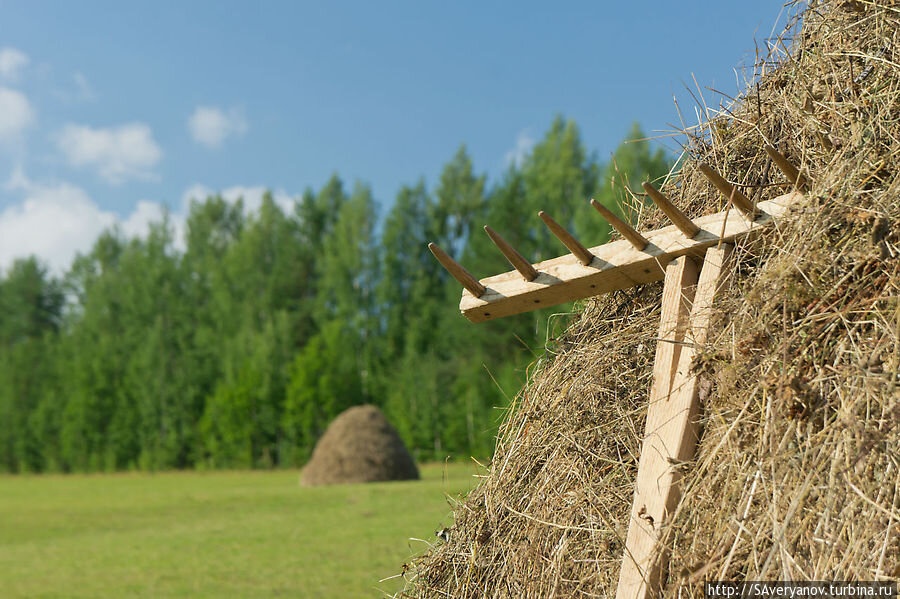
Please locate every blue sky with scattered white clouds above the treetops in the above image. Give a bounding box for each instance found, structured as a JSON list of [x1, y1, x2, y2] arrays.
[[0, 0, 783, 270]]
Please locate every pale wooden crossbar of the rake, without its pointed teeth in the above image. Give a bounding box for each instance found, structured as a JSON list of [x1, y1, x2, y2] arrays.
[[459, 192, 803, 322]]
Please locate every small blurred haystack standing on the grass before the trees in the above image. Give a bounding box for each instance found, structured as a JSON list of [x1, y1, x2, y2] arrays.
[[300, 405, 419, 486]]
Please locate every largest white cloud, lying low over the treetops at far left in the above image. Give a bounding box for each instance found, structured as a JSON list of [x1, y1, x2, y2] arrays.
[[0, 168, 184, 274]]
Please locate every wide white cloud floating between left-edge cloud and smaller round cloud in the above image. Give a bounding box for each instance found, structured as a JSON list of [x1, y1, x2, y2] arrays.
[[57, 123, 162, 184]]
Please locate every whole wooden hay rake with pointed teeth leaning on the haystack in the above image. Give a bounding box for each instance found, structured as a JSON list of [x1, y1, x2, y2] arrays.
[[428, 147, 807, 599]]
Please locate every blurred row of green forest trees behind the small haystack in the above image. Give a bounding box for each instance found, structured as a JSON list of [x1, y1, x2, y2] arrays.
[[0, 117, 672, 472]]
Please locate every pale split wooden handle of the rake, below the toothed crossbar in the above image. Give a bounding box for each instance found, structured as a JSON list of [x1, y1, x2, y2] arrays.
[[616, 244, 731, 599]]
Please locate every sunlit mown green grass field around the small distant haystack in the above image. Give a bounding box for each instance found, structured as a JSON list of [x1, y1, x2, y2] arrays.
[[0, 464, 475, 598]]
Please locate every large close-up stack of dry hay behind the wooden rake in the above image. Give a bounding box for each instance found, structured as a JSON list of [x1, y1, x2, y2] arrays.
[[404, 0, 900, 598]]
